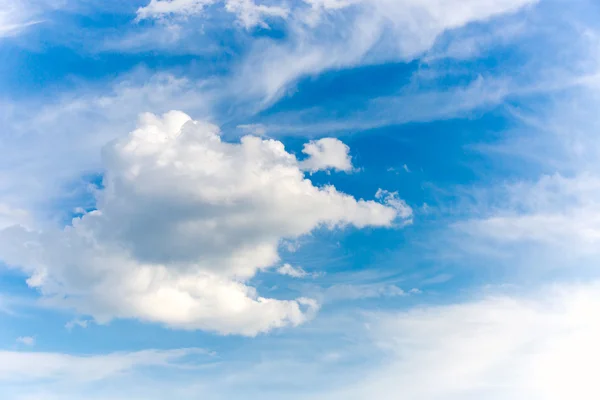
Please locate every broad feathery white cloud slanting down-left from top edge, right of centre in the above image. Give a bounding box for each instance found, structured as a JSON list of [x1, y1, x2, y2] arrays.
[[232, 0, 537, 105]]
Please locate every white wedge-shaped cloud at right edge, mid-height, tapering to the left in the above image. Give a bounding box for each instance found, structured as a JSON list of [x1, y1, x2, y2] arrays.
[[456, 174, 600, 254]]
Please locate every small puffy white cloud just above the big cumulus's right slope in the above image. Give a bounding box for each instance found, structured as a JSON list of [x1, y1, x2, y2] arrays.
[[300, 138, 353, 172]]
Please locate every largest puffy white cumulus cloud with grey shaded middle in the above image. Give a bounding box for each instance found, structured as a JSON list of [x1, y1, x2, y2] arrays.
[[0, 111, 410, 335]]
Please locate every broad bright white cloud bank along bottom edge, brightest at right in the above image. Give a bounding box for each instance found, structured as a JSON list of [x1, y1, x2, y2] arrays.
[[5, 282, 600, 400]]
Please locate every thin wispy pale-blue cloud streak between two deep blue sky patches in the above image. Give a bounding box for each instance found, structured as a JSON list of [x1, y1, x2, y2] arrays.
[[251, 71, 516, 136]]
